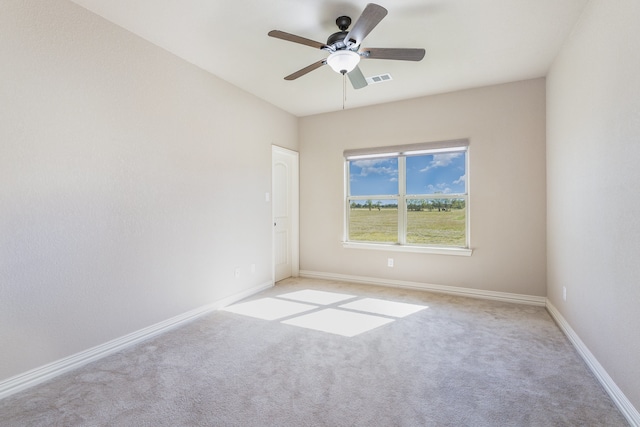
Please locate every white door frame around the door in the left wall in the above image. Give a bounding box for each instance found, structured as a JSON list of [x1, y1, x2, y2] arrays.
[[271, 145, 300, 284]]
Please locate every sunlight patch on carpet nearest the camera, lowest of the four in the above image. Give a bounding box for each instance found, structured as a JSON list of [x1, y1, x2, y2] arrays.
[[282, 308, 394, 337]]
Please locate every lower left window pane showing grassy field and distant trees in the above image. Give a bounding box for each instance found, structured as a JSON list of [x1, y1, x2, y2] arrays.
[[349, 200, 398, 243]]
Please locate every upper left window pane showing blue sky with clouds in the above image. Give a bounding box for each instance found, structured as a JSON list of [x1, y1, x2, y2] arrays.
[[349, 158, 398, 196]]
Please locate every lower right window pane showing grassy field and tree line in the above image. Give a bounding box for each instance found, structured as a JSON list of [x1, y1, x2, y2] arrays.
[[407, 199, 467, 247]]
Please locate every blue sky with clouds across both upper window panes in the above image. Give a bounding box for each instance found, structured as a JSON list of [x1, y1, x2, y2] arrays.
[[349, 152, 466, 196]]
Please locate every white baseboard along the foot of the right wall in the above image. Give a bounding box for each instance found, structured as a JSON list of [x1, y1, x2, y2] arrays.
[[546, 300, 640, 427]]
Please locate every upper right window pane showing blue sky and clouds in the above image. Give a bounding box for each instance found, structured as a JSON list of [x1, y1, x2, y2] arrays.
[[407, 151, 467, 194]]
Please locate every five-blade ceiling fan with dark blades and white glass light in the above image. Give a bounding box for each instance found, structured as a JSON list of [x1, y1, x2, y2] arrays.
[[269, 3, 425, 89]]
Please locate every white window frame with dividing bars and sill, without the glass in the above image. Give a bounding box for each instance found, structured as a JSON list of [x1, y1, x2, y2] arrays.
[[342, 139, 473, 256]]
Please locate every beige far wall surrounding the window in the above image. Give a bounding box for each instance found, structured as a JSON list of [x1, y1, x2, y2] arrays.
[[299, 79, 546, 296]]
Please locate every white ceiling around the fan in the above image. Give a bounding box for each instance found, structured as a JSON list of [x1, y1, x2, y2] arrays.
[[72, 0, 588, 117]]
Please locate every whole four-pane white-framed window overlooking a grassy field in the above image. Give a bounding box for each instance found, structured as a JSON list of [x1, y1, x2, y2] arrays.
[[345, 140, 470, 255]]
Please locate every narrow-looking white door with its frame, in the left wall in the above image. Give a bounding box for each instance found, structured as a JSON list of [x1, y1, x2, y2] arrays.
[[271, 146, 299, 282]]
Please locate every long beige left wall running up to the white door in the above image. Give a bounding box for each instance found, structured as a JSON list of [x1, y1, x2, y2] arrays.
[[0, 0, 297, 381]]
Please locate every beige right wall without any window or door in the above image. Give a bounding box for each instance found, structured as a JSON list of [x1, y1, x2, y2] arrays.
[[547, 0, 640, 408]]
